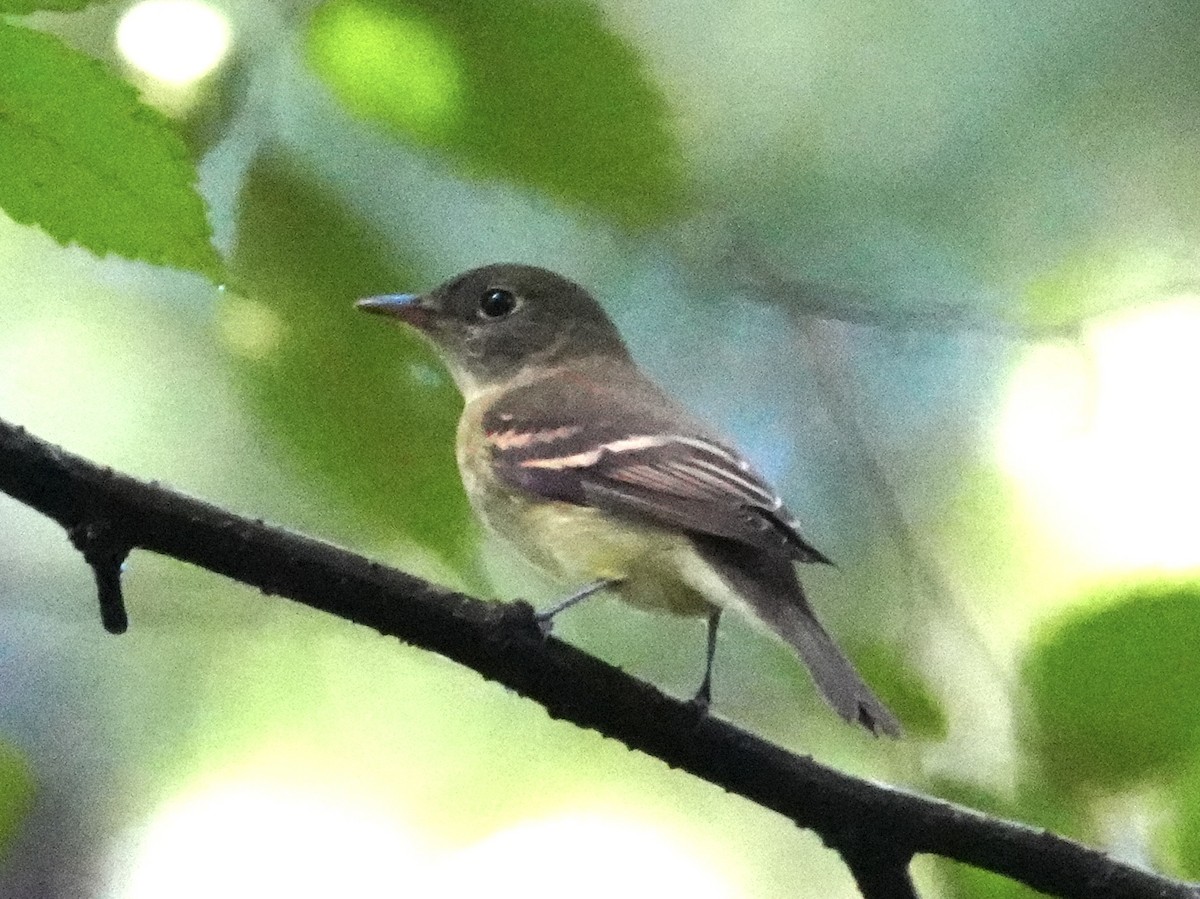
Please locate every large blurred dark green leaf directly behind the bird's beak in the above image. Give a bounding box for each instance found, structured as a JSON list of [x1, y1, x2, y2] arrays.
[[222, 156, 475, 558]]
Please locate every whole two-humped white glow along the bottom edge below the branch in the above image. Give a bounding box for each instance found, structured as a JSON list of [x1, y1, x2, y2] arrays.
[[107, 781, 742, 899]]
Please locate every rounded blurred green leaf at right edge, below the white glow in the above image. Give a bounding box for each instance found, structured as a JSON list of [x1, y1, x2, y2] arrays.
[[1024, 585, 1200, 789]]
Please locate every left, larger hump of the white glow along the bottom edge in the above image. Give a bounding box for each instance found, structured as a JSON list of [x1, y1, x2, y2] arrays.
[[114, 784, 426, 899]]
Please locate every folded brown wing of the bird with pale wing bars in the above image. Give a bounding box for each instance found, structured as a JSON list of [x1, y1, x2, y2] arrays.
[[482, 376, 828, 562]]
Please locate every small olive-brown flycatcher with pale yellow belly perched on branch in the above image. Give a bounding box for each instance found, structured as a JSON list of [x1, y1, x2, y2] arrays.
[[359, 265, 900, 736]]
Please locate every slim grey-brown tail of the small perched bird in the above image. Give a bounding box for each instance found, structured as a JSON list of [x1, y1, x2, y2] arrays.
[[697, 540, 901, 737]]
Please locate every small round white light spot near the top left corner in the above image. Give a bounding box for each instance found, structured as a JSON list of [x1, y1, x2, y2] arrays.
[[116, 0, 230, 86]]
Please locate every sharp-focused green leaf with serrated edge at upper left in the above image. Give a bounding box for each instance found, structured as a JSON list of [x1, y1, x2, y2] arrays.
[[0, 22, 221, 280]]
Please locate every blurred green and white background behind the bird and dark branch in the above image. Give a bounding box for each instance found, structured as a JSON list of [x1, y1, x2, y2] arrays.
[[0, 0, 1200, 899]]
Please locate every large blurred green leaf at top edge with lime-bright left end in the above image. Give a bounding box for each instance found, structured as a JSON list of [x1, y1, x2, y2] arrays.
[[307, 0, 683, 227]]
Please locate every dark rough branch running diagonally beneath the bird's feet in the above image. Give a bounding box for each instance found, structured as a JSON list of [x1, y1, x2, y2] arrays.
[[0, 421, 1200, 899]]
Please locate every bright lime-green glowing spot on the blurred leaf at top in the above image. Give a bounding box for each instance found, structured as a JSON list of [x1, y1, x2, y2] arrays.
[[308, 0, 462, 137]]
